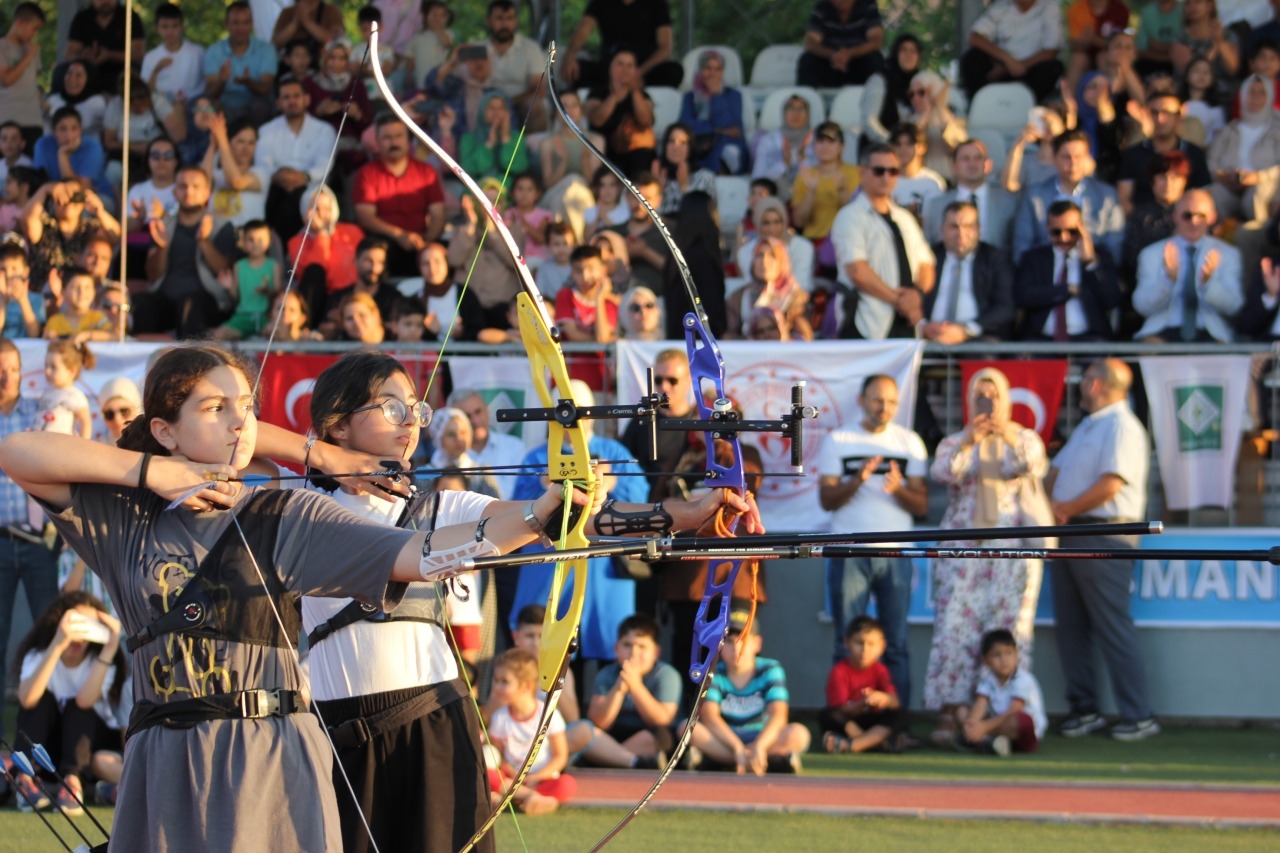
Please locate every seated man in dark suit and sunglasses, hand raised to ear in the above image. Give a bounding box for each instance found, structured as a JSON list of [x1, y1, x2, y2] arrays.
[[1014, 201, 1121, 343]]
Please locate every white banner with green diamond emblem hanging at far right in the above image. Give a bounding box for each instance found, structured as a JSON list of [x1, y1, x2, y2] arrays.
[[1138, 356, 1249, 510]]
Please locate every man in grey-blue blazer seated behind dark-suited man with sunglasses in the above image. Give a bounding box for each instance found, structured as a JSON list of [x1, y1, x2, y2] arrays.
[[1014, 131, 1124, 263]]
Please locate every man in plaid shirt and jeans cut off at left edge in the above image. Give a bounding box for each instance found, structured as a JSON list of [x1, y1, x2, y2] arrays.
[[0, 337, 58, 732]]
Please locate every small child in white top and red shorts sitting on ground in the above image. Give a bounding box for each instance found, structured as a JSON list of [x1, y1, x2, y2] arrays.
[[489, 648, 577, 815]]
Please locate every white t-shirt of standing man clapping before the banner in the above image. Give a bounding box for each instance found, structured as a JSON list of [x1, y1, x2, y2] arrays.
[[817, 423, 929, 533]]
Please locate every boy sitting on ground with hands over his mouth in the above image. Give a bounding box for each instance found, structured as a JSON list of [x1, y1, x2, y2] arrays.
[[586, 613, 684, 770]]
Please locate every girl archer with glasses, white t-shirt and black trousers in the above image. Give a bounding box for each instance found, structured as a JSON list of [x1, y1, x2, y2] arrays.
[[292, 351, 754, 853]]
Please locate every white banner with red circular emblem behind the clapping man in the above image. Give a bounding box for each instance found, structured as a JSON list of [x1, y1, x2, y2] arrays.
[[617, 339, 924, 532]]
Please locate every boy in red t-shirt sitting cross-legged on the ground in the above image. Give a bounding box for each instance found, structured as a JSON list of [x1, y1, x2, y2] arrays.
[[819, 616, 905, 752]]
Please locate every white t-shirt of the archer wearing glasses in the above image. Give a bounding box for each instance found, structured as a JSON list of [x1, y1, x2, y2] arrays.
[[302, 481, 493, 702]]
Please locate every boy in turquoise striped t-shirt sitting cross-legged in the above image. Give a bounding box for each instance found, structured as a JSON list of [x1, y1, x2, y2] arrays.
[[686, 610, 809, 776]]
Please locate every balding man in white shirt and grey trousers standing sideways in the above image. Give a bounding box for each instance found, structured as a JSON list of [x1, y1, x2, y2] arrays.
[[1044, 359, 1160, 740]]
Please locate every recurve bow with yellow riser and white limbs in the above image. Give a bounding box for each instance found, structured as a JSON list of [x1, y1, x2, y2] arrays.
[[369, 24, 595, 853]]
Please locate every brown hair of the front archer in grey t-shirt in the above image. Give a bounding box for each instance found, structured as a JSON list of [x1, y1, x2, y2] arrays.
[[117, 343, 257, 456]]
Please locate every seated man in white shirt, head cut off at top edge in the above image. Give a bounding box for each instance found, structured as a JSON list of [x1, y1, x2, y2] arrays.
[[960, 0, 1062, 102]]
